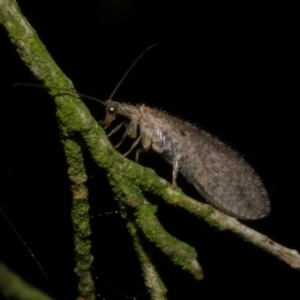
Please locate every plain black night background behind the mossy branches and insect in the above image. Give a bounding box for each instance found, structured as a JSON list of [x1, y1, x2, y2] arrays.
[[0, 0, 300, 300]]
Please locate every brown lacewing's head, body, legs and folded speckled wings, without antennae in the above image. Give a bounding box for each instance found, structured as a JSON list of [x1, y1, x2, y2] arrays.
[[99, 100, 270, 220]]
